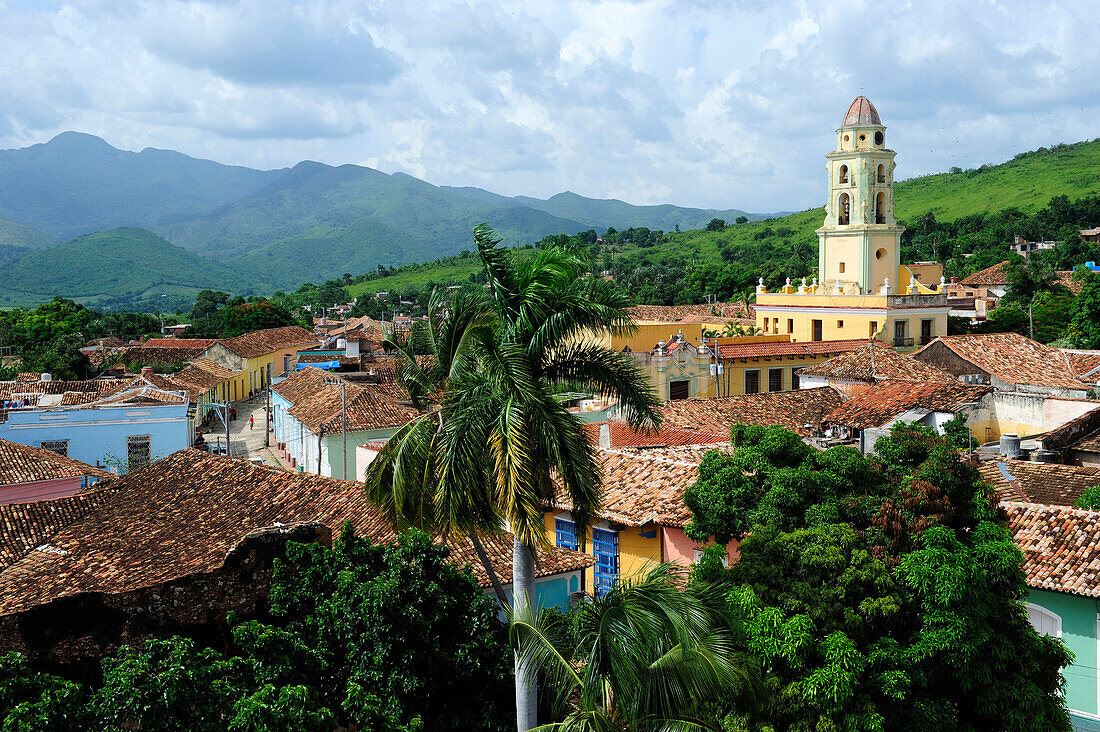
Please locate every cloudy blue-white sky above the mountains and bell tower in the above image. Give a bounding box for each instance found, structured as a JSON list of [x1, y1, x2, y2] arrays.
[[0, 0, 1100, 211]]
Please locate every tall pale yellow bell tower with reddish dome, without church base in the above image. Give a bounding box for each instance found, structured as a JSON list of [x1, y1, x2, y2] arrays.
[[817, 97, 904, 295]]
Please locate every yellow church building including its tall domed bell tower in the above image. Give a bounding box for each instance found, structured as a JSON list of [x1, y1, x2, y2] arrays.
[[756, 97, 949, 348]]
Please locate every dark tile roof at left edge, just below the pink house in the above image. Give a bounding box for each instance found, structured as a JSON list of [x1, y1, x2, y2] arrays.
[[0, 485, 113, 572]]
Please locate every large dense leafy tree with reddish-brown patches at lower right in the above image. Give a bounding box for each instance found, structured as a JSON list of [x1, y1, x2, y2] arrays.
[[685, 426, 1071, 732]]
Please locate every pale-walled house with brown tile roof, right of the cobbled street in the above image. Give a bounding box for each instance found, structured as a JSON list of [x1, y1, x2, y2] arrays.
[[272, 368, 418, 478]]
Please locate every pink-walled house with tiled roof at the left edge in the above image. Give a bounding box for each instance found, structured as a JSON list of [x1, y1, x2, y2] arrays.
[[0, 439, 111, 504]]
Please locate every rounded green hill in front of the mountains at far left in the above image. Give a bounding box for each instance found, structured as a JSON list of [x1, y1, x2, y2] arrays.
[[0, 229, 255, 310]]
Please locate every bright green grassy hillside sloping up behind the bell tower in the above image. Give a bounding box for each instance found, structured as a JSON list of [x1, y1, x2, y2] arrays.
[[354, 141, 1100, 294]]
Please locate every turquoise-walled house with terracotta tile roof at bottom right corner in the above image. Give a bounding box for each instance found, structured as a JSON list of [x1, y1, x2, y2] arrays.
[[1001, 502, 1100, 732]]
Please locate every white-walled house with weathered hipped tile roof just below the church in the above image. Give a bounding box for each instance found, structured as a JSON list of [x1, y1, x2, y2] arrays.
[[799, 340, 956, 396]]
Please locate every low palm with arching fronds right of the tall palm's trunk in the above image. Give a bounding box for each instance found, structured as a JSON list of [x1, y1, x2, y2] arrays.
[[509, 565, 760, 732]]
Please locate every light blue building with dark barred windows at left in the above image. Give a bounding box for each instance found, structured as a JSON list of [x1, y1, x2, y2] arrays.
[[0, 376, 190, 472]]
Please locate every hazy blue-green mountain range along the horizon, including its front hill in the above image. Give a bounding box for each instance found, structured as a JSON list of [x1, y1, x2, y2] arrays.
[[0, 132, 765, 309]]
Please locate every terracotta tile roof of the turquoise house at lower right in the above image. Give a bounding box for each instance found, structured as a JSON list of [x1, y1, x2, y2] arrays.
[[1001, 503, 1100, 598]]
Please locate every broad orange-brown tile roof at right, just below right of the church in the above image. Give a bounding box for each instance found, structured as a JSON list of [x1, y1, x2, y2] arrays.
[[913, 332, 1087, 390]]
